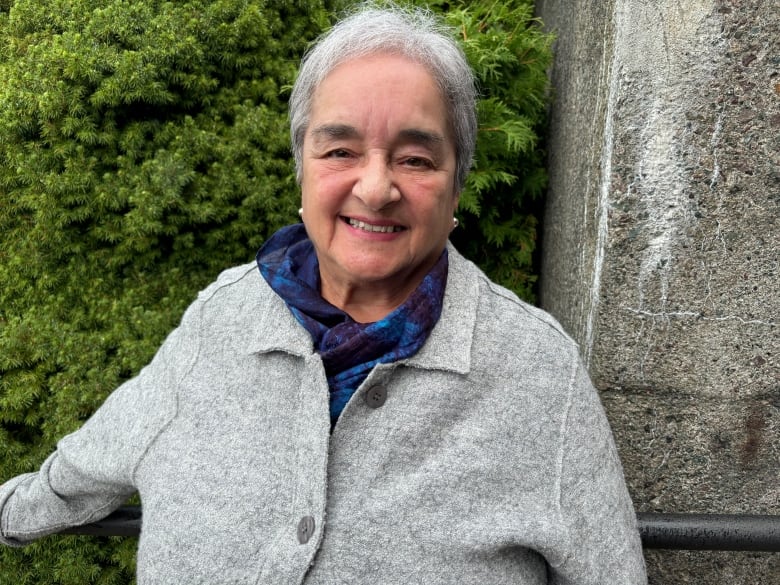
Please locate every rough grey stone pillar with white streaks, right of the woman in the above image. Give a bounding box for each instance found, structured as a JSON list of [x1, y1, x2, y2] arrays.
[[537, 0, 780, 585]]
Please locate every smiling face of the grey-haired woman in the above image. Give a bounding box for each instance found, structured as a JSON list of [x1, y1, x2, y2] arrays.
[[301, 55, 458, 308]]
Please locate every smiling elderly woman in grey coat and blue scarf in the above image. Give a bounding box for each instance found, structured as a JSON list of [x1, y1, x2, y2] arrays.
[[0, 2, 645, 585]]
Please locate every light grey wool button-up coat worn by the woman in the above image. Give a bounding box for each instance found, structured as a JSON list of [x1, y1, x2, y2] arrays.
[[0, 242, 645, 585]]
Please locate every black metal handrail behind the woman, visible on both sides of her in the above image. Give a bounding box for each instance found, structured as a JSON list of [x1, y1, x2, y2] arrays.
[[62, 506, 780, 552]]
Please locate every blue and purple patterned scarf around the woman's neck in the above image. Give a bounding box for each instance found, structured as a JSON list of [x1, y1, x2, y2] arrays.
[[257, 223, 448, 424]]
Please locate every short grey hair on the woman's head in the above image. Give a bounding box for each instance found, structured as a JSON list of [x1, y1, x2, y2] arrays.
[[289, 2, 477, 191]]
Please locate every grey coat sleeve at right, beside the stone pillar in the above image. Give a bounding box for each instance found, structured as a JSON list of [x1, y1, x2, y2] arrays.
[[550, 363, 647, 585]]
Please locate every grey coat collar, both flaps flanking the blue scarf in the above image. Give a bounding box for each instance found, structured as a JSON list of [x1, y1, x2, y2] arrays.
[[248, 244, 479, 374]]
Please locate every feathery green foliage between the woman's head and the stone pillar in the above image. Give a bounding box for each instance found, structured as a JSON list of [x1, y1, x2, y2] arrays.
[[438, 0, 552, 301]]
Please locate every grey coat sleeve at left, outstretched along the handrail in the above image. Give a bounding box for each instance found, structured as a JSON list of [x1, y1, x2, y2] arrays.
[[0, 296, 198, 546]]
